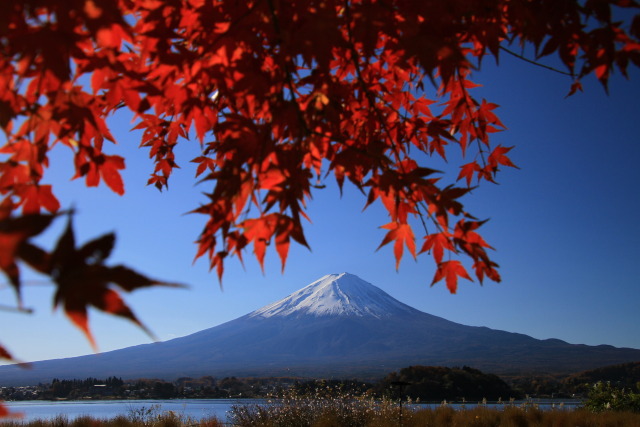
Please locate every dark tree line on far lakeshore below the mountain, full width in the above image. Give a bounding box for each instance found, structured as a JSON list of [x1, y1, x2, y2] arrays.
[[5, 362, 640, 402]]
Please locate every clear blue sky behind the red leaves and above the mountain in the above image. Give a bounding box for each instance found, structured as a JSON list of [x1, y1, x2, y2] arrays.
[[0, 50, 640, 360]]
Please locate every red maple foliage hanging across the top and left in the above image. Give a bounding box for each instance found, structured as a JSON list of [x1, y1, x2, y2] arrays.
[[0, 0, 640, 382]]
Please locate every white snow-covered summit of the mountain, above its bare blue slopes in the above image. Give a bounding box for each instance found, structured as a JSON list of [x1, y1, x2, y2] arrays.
[[249, 273, 416, 318]]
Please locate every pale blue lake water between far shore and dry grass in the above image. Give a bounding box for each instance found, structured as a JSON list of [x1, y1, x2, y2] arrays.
[[0, 399, 580, 424]]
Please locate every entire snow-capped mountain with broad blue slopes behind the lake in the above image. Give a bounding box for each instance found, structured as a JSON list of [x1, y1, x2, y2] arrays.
[[0, 273, 640, 386]]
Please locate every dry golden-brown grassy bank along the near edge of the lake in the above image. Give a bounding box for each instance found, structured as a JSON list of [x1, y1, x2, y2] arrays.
[[1, 402, 640, 427]]
